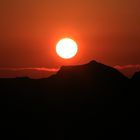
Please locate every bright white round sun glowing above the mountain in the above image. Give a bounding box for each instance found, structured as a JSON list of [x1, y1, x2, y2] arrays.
[[56, 38, 78, 59]]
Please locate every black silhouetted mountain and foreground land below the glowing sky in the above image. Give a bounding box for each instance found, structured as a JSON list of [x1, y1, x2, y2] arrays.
[[0, 61, 140, 140]]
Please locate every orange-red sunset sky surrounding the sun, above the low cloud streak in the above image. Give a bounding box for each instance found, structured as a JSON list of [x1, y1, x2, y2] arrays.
[[0, 0, 140, 77]]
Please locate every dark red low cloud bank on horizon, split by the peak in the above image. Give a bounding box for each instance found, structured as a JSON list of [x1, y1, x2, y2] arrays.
[[0, 61, 140, 79]]
